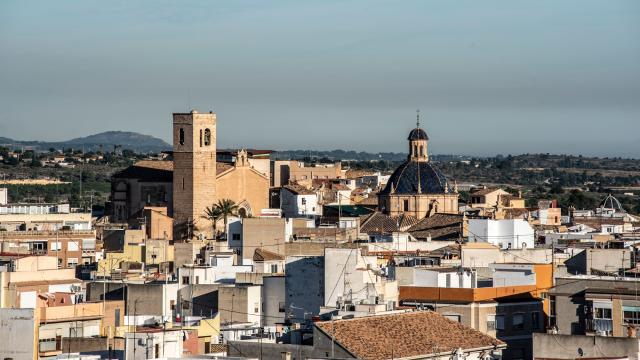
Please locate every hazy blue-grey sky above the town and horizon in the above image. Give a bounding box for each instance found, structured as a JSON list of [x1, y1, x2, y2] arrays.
[[0, 0, 640, 157]]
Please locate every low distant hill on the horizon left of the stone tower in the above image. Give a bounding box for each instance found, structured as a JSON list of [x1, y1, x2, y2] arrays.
[[0, 131, 171, 153]]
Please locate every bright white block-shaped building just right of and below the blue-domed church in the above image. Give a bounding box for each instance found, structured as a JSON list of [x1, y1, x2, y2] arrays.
[[469, 219, 535, 249]]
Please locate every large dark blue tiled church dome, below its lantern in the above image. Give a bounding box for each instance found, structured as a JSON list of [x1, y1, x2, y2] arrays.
[[380, 160, 452, 195]]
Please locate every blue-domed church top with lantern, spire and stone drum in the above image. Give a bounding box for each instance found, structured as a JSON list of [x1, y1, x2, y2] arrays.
[[378, 118, 458, 219]]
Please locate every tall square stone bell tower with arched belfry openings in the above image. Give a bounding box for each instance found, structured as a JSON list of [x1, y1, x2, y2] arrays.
[[173, 110, 217, 240]]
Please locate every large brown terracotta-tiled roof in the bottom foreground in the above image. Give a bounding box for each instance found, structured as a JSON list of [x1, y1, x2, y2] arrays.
[[316, 311, 504, 359]]
